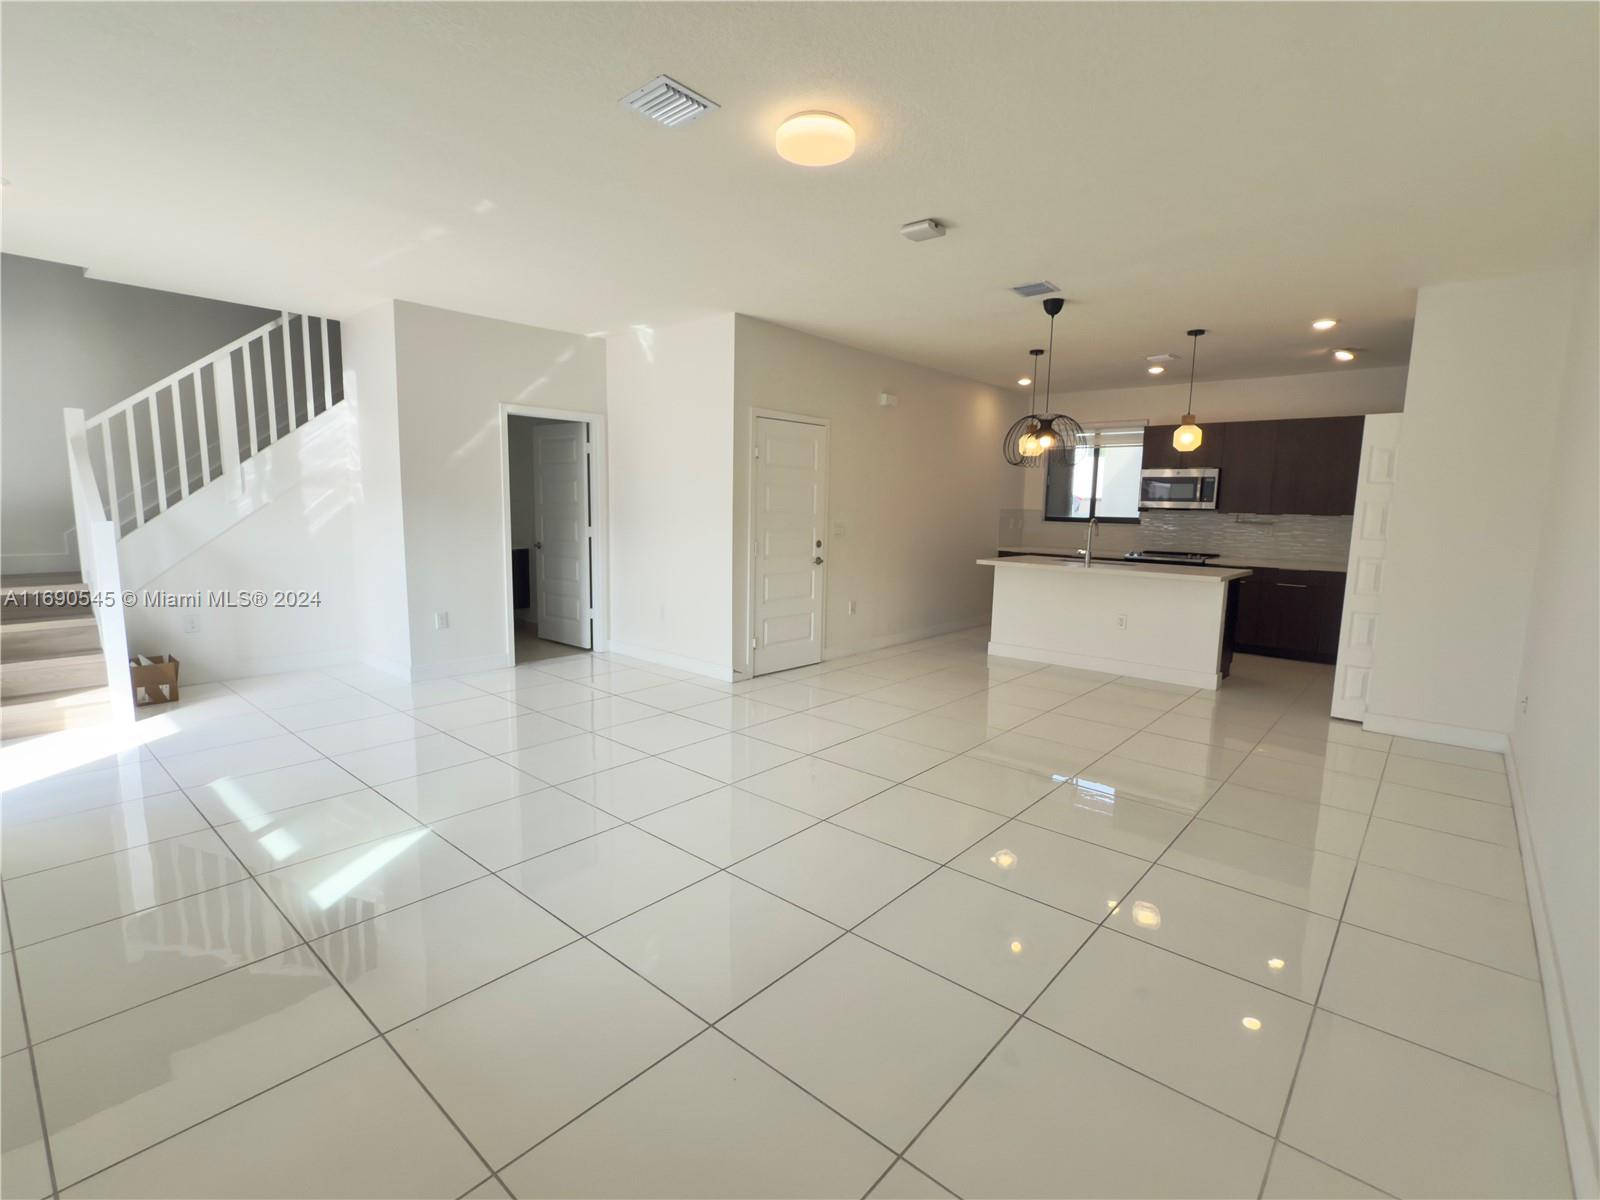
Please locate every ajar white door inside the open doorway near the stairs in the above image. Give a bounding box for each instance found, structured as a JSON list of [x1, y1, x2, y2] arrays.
[[533, 421, 592, 650]]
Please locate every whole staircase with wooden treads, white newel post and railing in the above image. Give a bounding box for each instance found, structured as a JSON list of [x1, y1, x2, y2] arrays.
[[0, 312, 349, 738]]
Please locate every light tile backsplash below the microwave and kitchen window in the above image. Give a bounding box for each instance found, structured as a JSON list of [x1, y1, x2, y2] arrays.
[[998, 509, 1355, 570]]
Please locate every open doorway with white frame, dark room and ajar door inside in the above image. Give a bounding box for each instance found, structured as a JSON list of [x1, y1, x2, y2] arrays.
[[501, 405, 605, 662]]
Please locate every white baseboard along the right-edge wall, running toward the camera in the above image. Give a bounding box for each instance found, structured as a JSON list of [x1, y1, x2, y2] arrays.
[[1506, 746, 1600, 1197]]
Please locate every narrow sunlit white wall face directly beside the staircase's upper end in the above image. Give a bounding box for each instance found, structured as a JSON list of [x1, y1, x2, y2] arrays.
[[341, 301, 411, 675]]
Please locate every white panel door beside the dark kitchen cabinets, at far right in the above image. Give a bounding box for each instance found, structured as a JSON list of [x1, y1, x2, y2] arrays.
[[1333, 413, 1400, 722]]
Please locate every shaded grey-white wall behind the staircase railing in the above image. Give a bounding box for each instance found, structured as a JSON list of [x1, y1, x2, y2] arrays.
[[0, 254, 277, 574]]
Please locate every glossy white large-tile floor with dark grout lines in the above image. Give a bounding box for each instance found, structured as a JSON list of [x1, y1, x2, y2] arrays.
[[0, 630, 1570, 1200]]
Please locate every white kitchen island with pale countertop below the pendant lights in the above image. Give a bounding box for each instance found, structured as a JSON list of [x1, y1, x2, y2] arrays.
[[978, 555, 1250, 690]]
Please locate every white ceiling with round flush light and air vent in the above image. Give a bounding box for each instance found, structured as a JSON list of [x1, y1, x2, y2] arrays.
[[0, 3, 1600, 387]]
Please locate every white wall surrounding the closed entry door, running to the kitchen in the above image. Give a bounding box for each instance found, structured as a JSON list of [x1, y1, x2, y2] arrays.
[[733, 315, 1034, 670]]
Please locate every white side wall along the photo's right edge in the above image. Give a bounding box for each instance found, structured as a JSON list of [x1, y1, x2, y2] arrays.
[[1510, 224, 1600, 1195]]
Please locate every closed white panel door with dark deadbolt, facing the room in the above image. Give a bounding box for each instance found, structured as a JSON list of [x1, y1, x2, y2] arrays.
[[750, 416, 827, 675]]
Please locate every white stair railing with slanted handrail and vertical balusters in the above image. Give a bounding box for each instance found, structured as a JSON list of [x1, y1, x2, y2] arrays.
[[83, 312, 342, 538]]
